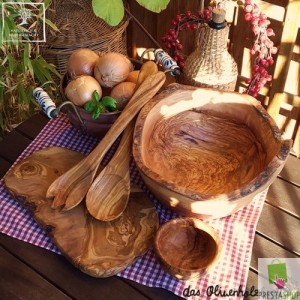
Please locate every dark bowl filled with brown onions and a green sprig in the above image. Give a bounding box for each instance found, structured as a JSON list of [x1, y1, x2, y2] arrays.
[[60, 48, 140, 137]]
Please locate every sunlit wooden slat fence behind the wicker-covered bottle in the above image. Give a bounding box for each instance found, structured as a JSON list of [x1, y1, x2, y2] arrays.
[[128, 0, 300, 157]]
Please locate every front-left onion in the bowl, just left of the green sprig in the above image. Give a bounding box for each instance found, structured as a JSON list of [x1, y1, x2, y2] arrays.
[[65, 75, 102, 106]]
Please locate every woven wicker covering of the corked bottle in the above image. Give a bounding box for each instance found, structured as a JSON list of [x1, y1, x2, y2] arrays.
[[181, 24, 238, 91]]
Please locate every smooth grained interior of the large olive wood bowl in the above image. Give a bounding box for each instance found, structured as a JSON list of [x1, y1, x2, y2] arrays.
[[139, 84, 288, 196]]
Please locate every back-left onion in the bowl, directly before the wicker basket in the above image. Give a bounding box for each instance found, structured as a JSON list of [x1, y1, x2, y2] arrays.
[[67, 48, 99, 78]]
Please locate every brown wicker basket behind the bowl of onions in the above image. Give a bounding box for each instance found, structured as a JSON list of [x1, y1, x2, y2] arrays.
[[42, 0, 129, 75]]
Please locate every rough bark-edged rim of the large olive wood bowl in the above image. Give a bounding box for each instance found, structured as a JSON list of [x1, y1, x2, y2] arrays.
[[133, 83, 292, 201]]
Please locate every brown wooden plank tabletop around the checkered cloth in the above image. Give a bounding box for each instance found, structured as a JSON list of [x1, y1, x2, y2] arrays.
[[0, 114, 300, 300]]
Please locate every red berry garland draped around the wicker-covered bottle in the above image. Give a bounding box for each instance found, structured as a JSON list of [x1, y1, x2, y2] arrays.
[[162, 0, 278, 97]]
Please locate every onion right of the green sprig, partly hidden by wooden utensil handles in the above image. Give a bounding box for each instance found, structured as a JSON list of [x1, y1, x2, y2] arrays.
[[110, 81, 136, 110]]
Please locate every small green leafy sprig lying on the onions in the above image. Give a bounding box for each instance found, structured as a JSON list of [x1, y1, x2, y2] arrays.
[[84, 90, 118, 120]]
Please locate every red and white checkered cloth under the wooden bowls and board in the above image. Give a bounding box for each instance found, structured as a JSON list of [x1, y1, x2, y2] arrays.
[[0, 114, 267, 299]]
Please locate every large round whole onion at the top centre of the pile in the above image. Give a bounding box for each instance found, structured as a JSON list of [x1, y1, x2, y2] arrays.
[[94, 52, 133, 87]]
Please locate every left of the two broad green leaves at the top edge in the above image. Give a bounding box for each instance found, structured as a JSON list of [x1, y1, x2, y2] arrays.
[[92, 0, 124, 26]]
